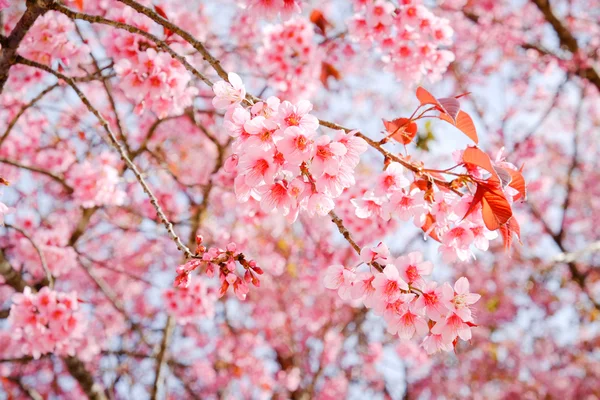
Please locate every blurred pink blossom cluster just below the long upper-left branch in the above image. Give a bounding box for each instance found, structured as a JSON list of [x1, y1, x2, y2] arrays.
[[115, 48, 198, 118]]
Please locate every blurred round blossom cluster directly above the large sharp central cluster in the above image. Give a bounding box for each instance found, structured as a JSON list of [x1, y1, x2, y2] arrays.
[[256, 18, 323, 99]]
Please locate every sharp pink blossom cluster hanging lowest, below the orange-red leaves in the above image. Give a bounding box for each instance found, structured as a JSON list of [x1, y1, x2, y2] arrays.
[[324, 244, 481, 353]]
